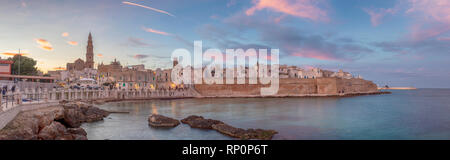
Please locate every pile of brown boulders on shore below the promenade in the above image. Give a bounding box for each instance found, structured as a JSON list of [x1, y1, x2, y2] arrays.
[[0, 102, 109, 140]]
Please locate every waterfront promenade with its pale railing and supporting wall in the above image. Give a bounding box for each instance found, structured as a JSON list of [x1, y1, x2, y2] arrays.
[[0, 88, 199, 129]]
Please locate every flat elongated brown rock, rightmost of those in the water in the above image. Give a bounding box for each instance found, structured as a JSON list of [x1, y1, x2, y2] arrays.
[[212, 124, 278, 140]]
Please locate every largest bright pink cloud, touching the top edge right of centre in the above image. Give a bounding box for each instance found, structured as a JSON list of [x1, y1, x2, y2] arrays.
[[245, 0, 329, 22]]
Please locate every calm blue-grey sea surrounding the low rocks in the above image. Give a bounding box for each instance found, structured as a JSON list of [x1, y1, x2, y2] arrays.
[[82, 89, 450, 140]]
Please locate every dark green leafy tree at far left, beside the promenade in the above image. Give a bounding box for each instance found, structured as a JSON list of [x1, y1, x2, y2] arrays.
[[8, 55, 38, 76]]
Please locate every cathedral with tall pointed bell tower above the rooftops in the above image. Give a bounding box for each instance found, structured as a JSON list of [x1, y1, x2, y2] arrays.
[[66, 33, 94, 71]]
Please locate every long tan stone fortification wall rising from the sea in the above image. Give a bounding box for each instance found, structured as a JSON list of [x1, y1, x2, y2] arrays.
[[195, 77, 378, 97]]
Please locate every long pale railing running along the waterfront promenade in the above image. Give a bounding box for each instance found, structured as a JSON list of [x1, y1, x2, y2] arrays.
[[0, 88, 198, 112]]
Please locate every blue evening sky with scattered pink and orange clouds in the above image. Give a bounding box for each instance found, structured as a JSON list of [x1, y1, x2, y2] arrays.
[[0, 0, 450, 88]]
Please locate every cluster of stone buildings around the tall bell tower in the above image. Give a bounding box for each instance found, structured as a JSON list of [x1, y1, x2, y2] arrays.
[[48, 33, 174, 89]]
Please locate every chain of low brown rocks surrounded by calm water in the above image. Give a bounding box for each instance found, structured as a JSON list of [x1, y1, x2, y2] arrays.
[[148, 114, 278, 140]]
